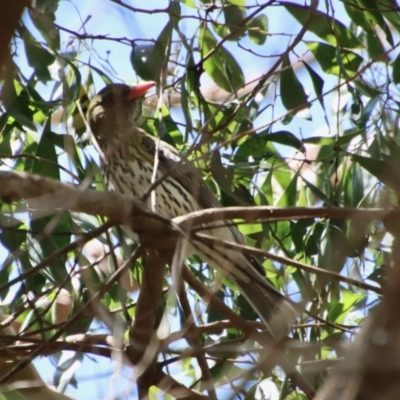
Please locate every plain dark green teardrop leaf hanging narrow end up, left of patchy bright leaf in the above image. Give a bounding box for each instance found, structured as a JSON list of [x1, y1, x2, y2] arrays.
[[280, 54, 307, 110]]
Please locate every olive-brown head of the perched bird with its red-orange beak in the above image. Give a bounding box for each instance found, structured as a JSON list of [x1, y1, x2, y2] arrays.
[[87, 82, 155, 140]]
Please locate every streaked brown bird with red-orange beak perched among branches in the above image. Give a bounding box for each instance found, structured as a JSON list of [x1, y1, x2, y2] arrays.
[[87, 82, 299, 340]]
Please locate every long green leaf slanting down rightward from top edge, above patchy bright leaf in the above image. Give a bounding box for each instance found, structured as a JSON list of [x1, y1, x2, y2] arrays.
[[283, 2, 362, 48]]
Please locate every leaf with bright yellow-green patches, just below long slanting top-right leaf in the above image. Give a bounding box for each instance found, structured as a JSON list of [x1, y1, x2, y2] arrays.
[[306, 42, 363, 76]]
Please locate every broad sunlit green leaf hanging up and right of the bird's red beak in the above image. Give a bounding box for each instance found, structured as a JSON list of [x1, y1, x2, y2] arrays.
[[200, 25, 244, 93]]
